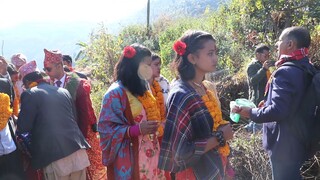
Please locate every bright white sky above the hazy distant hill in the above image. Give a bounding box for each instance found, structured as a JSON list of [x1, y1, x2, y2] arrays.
[[0, 0, 147, 29]]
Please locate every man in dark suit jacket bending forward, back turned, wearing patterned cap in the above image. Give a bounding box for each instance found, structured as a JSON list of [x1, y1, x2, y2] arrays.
[[17, 61, 90, 179]]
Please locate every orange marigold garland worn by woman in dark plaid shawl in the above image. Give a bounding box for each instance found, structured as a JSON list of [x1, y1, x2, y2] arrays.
[[202, 90, 230, 157]]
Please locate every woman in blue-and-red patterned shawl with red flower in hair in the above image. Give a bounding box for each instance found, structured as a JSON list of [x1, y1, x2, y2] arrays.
[[98, 44, 165, 179]]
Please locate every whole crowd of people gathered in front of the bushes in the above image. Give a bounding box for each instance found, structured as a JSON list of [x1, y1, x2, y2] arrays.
[[0, 27, 312, 180]]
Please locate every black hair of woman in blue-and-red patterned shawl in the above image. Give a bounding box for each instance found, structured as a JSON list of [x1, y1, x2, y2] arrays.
[[114, 43, 151, 96]]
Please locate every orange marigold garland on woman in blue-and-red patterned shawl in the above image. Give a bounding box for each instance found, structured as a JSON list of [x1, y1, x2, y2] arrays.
[[138, 91, 164, 137]]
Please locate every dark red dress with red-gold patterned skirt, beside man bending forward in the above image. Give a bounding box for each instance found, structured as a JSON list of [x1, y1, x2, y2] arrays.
[[63, 73, 107, 180]]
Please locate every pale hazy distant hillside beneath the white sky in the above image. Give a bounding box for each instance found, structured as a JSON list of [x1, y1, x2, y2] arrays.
[[0, 0, 218, 68]]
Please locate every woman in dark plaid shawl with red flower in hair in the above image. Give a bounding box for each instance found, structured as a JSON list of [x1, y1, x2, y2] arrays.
[[158, 31, 233, 179]]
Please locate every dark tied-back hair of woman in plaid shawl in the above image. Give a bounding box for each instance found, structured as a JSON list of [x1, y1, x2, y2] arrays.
[[172, 30, 215, 81]]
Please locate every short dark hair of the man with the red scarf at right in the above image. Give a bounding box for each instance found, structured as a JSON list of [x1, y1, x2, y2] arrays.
[[284, 26, 311, 49]]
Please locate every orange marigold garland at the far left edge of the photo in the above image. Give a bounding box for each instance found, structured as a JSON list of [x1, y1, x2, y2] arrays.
[[0, 93, 12, 130]]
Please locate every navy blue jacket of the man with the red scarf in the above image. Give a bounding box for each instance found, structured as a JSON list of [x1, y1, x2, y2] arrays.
[[250, 57, 312, 158]]
